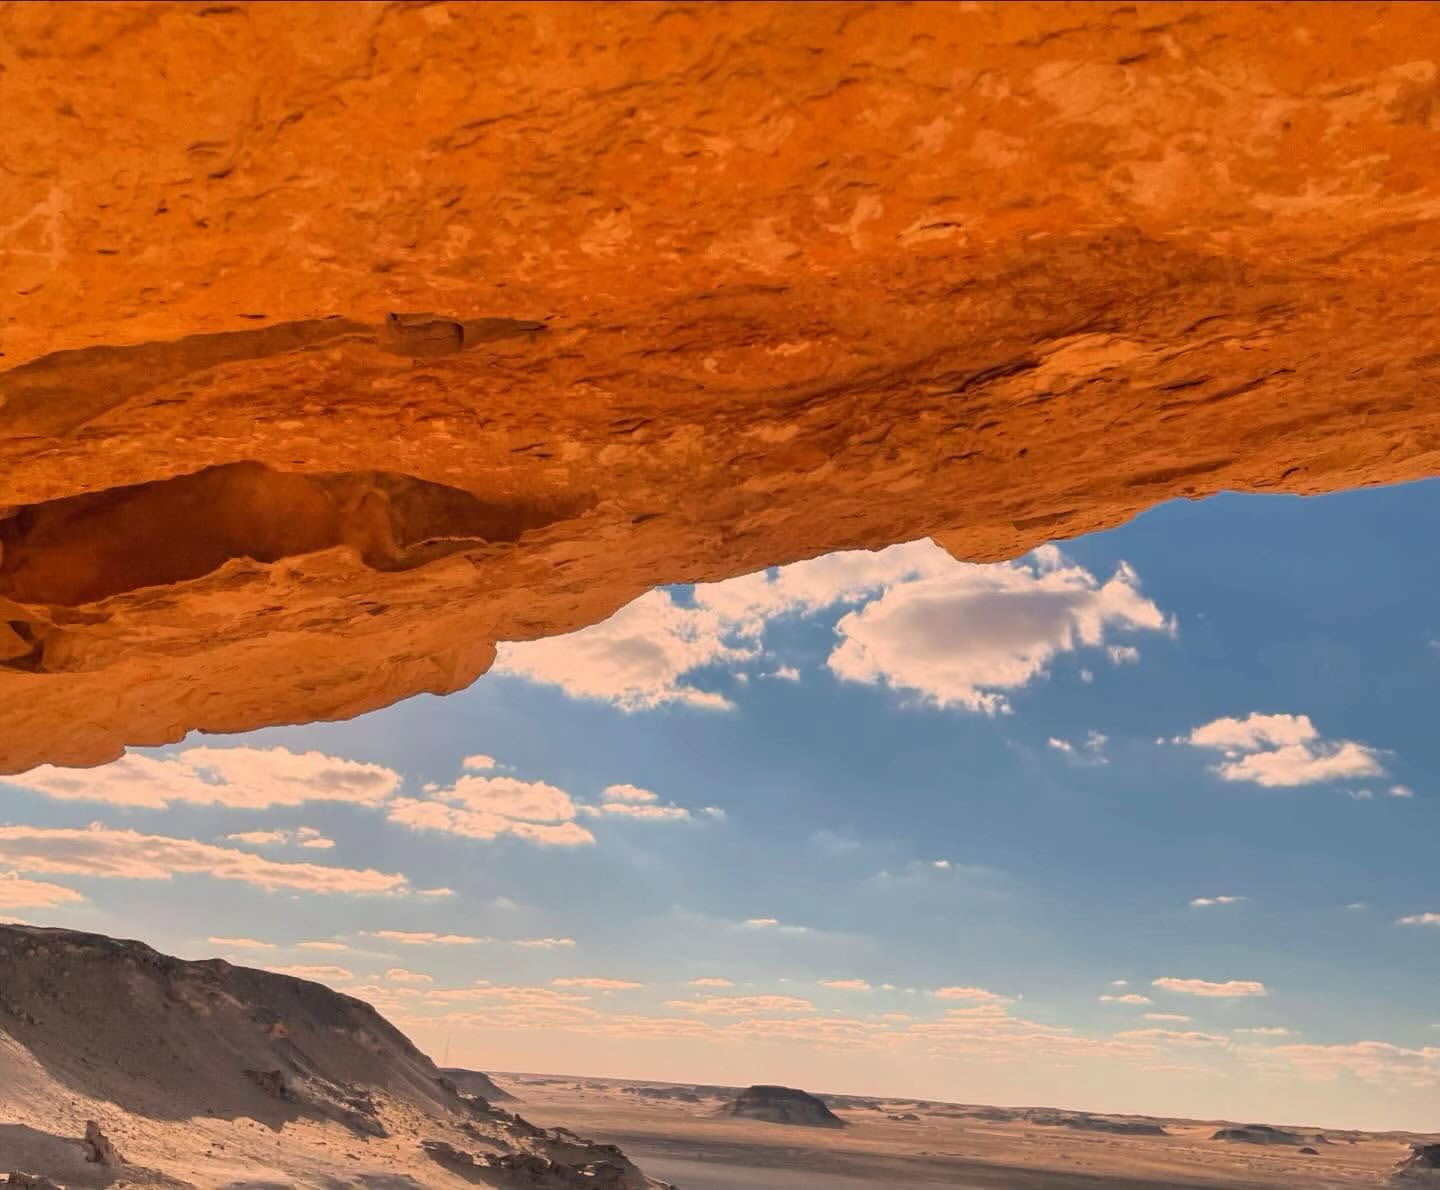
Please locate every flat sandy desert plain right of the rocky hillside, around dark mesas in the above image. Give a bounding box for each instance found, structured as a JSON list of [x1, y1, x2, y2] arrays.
[[495, 1075, 1410, 1190]]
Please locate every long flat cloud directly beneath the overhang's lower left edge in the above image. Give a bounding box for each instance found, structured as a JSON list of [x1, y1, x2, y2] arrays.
[[4, 748, 400, 810]]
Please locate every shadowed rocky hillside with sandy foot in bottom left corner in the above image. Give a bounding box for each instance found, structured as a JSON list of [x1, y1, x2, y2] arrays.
[[0, 925, 660, 1190]]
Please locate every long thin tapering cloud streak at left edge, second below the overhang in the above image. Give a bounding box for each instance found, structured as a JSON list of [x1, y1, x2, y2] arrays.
[[0, 823, 406, 893]]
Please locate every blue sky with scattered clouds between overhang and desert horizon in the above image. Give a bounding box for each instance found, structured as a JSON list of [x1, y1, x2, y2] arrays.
[[0, 484, 1440, 1128]]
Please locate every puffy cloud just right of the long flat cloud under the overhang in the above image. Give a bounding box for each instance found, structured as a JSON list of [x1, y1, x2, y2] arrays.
[[386, 775, 595, 847]]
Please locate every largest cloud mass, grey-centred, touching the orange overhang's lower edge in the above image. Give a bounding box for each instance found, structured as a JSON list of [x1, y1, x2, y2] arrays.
[[495, 542, 1174, 712]]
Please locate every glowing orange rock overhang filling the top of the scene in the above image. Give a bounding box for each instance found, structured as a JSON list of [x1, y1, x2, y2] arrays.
[[0, 3, 1440, 771]]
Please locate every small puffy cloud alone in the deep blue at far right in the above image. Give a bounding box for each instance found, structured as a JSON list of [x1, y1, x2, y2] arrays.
[[1175, 712, 1385, 788]]
